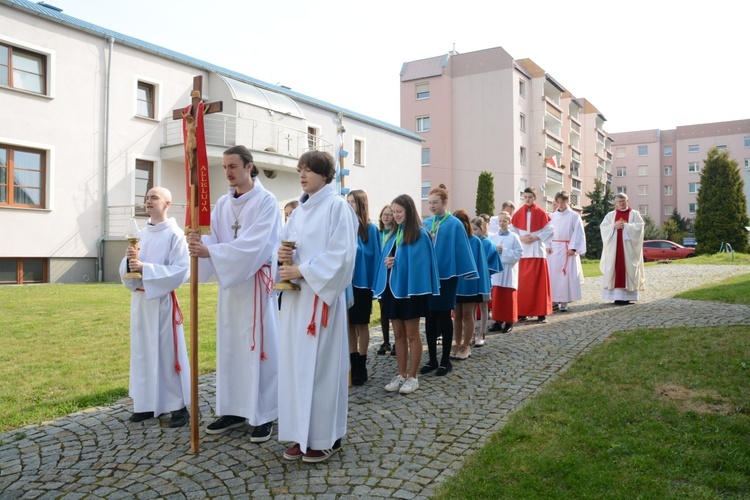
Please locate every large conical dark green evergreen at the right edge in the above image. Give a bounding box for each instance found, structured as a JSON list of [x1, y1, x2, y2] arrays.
[[694, 147, 750, 254]]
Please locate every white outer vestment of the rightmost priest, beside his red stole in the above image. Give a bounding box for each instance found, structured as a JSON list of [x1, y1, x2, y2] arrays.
[[599, 208, 646, 300]]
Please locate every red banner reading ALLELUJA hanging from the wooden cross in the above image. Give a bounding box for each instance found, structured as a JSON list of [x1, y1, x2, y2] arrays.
[[182, 102, 211, 234]]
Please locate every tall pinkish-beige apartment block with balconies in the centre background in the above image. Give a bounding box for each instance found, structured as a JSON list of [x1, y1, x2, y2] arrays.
[[400, 47, 612, 216]]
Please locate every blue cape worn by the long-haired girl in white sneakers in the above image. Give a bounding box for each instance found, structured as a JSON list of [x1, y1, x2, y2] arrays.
[[374, 227, 440, 299]]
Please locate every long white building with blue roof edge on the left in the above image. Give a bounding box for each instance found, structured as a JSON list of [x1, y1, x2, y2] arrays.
[[0, 0, 422, 283]]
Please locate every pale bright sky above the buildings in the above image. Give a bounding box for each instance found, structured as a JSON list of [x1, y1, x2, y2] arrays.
[[46, 0, 750, 133]]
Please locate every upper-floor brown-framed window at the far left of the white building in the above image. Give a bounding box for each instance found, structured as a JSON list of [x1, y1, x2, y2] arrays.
[[0, 43, 47, 94]]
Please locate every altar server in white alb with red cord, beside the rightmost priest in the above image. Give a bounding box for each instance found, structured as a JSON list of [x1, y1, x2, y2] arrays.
[[547, 191, 586, 312]]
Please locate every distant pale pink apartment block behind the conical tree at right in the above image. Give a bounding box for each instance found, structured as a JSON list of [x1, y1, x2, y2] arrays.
[[611, 120, 750, 224]]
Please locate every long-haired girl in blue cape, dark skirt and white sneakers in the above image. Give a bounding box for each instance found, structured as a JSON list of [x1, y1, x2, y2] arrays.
[[375, 194, 440, 394]]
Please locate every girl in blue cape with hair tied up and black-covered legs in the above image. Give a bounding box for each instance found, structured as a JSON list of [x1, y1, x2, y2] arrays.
[[420, 184, 479, 376]]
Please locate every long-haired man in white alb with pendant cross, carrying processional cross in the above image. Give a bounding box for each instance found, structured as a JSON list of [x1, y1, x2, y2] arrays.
[[188, 146, 286, 443]]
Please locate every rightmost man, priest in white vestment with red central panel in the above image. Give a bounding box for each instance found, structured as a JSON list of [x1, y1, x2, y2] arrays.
[[599, 193, 646, 305]]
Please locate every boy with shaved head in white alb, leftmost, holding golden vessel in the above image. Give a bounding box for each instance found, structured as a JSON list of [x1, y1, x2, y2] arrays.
[[120, 187, 190, 427]]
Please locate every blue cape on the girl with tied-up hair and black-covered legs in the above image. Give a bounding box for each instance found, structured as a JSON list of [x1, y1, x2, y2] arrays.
[[424, 215, 479, 280]]
